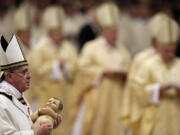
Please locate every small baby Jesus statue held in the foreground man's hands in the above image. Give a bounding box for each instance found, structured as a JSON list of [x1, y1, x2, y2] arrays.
[[31, 97, 63, 127]]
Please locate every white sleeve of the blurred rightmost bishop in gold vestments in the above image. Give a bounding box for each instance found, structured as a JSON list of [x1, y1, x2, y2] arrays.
[[150, 83, 160, 104]]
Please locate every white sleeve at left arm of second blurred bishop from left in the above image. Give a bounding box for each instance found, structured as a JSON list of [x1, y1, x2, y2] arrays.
[[50, 60, 62, 80]]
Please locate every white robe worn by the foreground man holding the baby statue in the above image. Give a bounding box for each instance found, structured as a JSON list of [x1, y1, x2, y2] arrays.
[[0, 81, 34, 135]]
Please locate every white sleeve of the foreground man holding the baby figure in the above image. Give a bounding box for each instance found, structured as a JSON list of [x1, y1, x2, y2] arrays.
[[0, 107, 34, 135]]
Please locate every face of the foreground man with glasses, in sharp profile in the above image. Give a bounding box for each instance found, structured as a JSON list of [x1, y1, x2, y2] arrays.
[[7, 66, 32, 93]]
